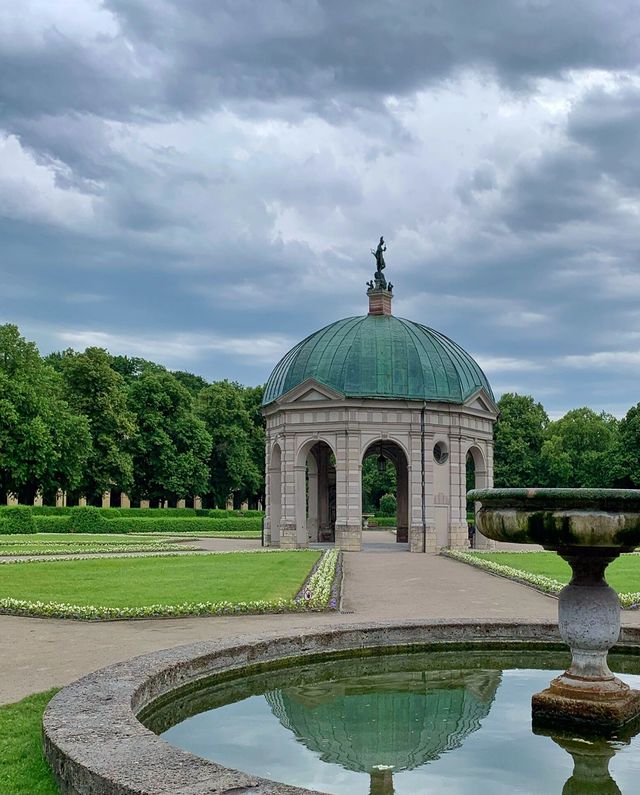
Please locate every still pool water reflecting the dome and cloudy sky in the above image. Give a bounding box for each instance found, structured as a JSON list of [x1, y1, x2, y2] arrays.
[[142, 651, 640, 795]]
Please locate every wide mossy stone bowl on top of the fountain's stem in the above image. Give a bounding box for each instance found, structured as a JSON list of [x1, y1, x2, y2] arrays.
[[467, 488, 640, 552]]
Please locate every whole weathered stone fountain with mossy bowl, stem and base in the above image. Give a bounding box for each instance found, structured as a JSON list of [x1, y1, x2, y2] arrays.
[[469, 489, 640, 731]]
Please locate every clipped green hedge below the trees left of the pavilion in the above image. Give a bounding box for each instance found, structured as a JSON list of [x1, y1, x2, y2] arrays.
[[0, 506, 262, 535]]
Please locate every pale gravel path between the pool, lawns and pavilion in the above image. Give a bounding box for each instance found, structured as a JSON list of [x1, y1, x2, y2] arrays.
[[0, 531, 640, 703]]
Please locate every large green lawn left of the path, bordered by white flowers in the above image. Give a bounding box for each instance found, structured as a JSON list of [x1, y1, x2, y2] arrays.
[[0, 550, 320, 607]]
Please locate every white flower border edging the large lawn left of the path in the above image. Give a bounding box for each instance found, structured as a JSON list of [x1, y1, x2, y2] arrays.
[[0, 549, 340, 621]]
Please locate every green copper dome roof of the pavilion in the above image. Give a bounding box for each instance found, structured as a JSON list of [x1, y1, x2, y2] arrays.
[[263, 315, 493, 405]]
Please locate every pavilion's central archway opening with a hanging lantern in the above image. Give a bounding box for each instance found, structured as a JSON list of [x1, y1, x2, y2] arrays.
[[362, 439, 409, 543]]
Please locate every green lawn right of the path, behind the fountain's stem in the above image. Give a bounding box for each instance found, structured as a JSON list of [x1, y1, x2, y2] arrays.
[[470, 552, 640, 593]]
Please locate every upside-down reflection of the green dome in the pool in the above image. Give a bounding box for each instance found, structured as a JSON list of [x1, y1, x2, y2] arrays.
[[265, 671, 500, 795]]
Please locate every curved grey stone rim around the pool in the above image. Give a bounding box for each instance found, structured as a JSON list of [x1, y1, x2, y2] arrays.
[[43, 621, 640, 795]]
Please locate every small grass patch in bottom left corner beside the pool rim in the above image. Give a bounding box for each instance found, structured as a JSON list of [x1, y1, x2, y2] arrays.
[[0, 690, 58, 795]]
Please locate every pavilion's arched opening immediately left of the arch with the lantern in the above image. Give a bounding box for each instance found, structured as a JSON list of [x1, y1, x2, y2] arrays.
[[295, 435, 336, 546]]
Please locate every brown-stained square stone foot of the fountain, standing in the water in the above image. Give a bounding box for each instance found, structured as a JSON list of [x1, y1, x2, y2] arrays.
[[531, 674, 640, 731]]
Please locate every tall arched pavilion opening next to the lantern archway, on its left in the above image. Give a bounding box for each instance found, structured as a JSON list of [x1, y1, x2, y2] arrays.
[[301, 441, 336, 543]]
